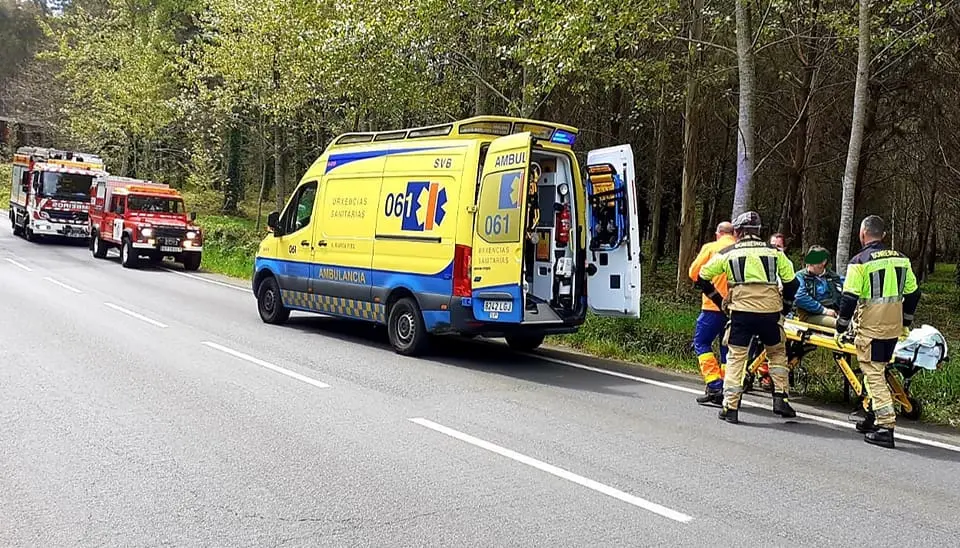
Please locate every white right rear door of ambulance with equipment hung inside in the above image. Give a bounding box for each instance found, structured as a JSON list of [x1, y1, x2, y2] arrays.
[[586, 145, 642, 318]]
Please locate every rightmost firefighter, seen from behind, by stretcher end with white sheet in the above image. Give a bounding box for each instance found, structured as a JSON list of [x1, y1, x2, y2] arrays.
[[837, 215, 920, 448]]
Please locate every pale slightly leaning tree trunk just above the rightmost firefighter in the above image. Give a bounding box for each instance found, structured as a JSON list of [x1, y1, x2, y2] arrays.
[[837, 0, 870, 275]]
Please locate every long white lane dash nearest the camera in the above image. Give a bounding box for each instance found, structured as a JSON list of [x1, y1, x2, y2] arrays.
[[408, 418, 693, 523]]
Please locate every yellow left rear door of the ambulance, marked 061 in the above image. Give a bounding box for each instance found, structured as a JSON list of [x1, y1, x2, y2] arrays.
[[472, 133, 532, 323]]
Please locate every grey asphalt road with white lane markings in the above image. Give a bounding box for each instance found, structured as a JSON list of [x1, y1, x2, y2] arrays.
[[0, 223, 960, 547]]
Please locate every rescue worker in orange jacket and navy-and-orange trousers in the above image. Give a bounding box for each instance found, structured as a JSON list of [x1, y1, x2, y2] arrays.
[[687, 221, 737, 406]]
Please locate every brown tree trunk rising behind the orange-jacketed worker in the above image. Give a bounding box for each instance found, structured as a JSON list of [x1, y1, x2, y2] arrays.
[[677, 0, 704, 292]]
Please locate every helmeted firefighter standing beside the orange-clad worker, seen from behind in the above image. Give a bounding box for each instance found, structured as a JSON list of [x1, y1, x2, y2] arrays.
[[698, 211, 800, 424]]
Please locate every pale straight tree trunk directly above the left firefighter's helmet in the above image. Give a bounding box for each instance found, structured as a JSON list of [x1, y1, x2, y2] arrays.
[[732, 0, 756, 219]]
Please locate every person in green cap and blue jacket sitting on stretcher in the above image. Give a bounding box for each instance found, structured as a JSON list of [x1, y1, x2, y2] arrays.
[[794, 245, 843, 328]]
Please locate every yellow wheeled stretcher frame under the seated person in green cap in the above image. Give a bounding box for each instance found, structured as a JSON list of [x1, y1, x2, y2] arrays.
[[744, 318, 944, 420]]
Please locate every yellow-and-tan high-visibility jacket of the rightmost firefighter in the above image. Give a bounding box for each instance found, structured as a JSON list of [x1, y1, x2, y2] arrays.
[[837, 242, 920, 339]]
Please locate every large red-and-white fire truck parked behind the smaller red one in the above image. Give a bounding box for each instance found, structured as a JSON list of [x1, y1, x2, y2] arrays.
[[9, 147, 106, 241]]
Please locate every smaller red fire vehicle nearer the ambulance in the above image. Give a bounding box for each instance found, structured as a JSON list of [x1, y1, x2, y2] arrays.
[[90, 175, 203, 270]]
